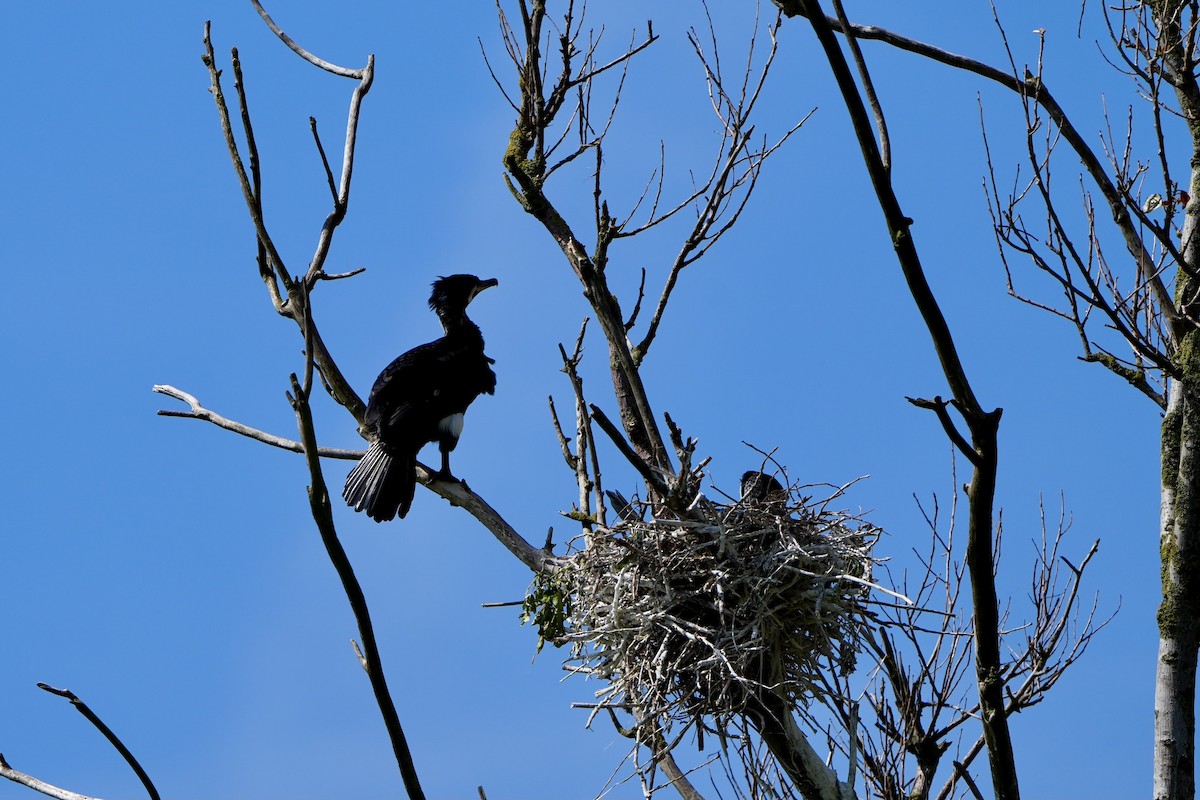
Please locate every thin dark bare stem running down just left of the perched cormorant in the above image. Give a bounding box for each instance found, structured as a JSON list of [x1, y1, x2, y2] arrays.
[[288, 309, 425, 800]]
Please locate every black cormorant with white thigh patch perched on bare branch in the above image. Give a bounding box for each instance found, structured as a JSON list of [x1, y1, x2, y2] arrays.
[[342, 275, 499, 522]]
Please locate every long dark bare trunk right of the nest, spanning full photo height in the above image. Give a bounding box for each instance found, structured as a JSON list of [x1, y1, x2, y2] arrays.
[[797, 0, 1020, 800]]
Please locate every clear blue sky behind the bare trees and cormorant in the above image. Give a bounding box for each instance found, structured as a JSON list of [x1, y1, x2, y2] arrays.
[[0, 0, 1161, 799]]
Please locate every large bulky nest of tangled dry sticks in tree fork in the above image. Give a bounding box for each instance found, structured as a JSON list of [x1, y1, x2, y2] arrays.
[[556, 482, 880, 729]]
